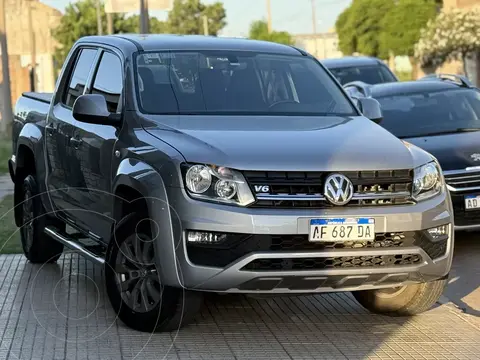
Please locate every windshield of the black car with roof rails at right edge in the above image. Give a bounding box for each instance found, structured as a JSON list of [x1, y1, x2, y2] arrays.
[[376, 89, 480, 137]]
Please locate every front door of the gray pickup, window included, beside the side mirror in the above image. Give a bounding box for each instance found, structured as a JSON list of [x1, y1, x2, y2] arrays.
[[66, 49, 124, 240]]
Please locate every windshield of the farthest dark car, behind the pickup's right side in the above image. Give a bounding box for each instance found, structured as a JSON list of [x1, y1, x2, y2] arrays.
[[329, 64, 397, 85]]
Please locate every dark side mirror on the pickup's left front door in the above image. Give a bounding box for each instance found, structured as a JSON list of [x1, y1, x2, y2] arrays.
[[72, 94, 120, 126]]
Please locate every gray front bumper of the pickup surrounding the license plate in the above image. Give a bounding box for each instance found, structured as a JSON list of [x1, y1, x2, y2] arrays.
[[159, 188, 454, 293]]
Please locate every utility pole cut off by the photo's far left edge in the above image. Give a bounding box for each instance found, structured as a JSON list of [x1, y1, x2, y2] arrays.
[[0, 0, 13, 133]]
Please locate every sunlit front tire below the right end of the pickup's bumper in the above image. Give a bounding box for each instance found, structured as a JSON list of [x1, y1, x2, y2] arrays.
[[352, 278, 447, 316]]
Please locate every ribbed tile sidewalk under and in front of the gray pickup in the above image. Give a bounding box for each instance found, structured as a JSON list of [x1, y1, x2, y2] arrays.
[[0, 250, 480, 360]]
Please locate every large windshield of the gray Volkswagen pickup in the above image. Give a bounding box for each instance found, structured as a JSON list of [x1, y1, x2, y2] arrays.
[[136, 51, 356, 115]]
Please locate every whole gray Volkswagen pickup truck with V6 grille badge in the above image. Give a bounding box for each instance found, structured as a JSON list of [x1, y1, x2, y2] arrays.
[[9, 35, 454, 331]]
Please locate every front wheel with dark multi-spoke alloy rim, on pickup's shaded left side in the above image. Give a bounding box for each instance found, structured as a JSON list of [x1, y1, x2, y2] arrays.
[[105, 212, 203, 333]]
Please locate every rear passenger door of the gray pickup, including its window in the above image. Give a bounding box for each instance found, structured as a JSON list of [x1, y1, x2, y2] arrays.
[[45, 47, 99, 219]]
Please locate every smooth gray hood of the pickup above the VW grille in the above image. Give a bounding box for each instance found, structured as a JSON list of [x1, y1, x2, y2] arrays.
[[145, 115, 430, 171]]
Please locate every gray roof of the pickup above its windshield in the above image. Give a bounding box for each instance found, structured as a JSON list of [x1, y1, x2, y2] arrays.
[[88, 34, 301, 55]]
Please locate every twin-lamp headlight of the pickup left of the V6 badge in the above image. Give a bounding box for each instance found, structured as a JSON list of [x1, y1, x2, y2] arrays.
[[183, 165, 255, 206]]
